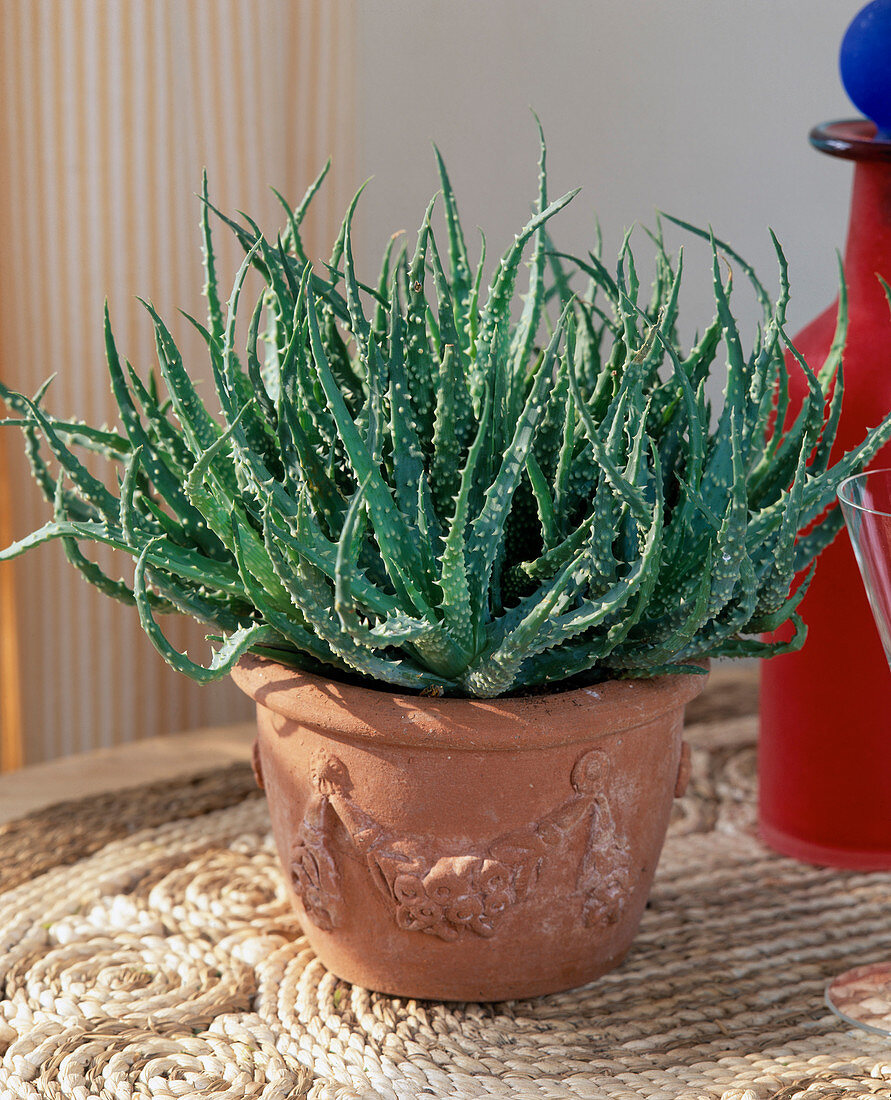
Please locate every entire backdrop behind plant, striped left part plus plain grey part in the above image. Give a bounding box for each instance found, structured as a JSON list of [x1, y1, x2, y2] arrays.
[[0, 0, 860, 759]]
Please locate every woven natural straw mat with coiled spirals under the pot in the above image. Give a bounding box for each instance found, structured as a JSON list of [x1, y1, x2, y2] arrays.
[[0, 678, 891, 1100]]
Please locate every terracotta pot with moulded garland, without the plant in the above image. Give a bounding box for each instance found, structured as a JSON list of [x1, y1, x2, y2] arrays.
[[233, 656, 705, 1001]]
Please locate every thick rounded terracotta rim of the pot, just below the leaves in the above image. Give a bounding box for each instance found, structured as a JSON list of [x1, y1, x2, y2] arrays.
[[231, 653, 708, 751]]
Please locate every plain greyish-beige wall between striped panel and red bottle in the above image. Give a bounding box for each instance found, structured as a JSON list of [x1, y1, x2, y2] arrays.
[[359, 0, 862, 352]]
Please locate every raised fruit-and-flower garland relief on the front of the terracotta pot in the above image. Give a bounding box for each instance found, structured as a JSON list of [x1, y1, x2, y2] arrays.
[[290, 749, 630, 941]]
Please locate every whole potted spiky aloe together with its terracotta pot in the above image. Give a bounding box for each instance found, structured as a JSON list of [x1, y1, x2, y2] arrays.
[[0, 133, 891, 1000]]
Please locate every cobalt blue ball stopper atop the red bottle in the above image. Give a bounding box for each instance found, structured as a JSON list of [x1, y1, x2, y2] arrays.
[[838, 0, 891, 138]]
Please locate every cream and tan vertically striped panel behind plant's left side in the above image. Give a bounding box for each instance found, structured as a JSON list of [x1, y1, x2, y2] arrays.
[[0, 0, 355, 767]]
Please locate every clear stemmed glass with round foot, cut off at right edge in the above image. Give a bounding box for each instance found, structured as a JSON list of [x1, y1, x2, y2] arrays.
[[826, 470, 891, 1035]]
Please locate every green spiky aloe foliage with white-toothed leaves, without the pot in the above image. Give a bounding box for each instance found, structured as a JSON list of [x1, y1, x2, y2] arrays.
[[0, 130, 891, 696]]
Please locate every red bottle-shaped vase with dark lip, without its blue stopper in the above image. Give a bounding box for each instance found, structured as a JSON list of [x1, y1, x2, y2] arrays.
[[759, 122, 891, 870]]
